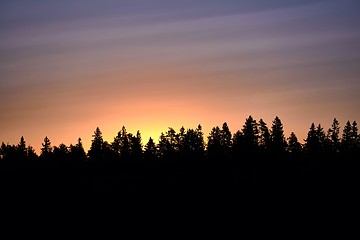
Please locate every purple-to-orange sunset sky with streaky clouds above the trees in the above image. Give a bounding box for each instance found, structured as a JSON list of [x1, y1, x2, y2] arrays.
[[0, 0, 360, 153]]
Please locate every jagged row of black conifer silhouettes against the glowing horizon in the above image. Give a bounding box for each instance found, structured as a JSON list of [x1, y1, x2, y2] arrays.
[[0, 116, 360, 168]]
